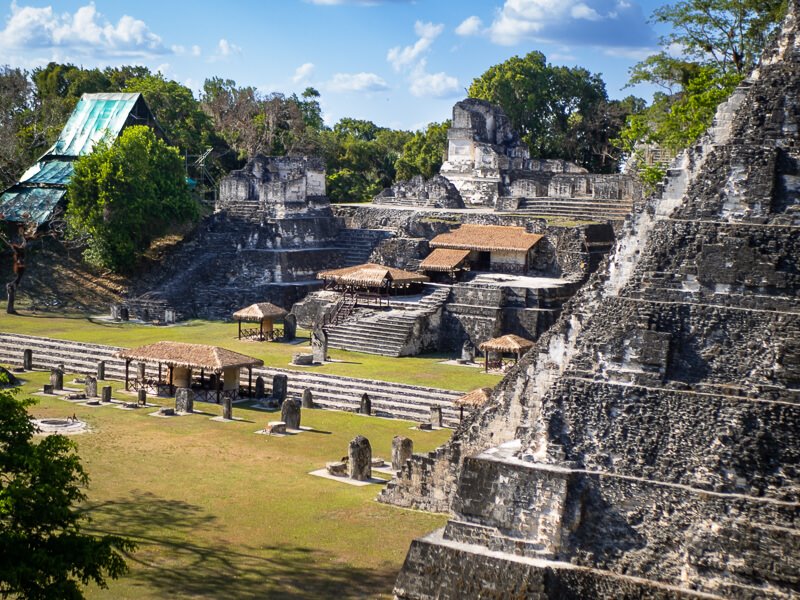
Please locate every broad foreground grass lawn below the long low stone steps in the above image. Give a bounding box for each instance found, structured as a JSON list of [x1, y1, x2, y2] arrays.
[[15, 372, 450, 599]]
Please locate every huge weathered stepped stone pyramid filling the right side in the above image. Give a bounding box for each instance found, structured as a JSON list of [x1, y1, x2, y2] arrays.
[[381, 5, 800, 599]]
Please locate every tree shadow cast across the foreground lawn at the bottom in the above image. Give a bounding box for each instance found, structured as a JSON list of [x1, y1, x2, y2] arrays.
[[84, 493, 396, 599]]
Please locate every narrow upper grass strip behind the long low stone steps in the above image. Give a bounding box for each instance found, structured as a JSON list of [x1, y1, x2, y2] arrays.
[[0, 310, 501, 392]]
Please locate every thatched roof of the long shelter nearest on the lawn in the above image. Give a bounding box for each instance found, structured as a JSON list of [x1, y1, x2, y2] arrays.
[[115, 342, 264, 372]]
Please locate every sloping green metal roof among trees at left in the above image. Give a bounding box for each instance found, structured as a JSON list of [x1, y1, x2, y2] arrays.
[[0, 93, 163, 225]]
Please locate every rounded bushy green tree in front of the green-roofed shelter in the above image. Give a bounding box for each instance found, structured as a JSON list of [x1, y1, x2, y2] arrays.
[[67, 126, 198, 272]]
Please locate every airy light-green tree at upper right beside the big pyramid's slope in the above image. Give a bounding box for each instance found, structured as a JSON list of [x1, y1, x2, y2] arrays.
[[616, 0, 786, 176]]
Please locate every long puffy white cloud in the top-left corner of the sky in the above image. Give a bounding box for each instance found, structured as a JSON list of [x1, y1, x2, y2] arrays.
[[0, 2, 170, 60]]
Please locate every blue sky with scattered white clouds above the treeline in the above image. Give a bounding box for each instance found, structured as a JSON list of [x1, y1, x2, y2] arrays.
[[0, 0, 676, 129]]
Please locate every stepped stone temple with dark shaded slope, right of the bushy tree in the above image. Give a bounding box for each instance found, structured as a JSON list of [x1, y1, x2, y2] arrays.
[[130, 156, 345, 320]]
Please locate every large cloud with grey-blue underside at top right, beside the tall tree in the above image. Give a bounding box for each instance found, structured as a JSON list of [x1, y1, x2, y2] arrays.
[[488, 0, 656, 48]]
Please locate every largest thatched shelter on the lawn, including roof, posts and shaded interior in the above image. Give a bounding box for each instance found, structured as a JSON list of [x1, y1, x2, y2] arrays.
[[115, 342, 264, 404]]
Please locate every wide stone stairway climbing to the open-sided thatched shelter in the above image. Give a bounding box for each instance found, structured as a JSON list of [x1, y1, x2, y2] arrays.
[[325, 284, 450, 357]]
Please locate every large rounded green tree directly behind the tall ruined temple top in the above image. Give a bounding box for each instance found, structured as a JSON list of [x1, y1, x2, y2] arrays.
[[469, 52, 622, 169]]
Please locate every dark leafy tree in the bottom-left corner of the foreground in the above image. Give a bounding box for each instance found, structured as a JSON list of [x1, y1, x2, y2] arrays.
[[0, 389, 135, 599]]
